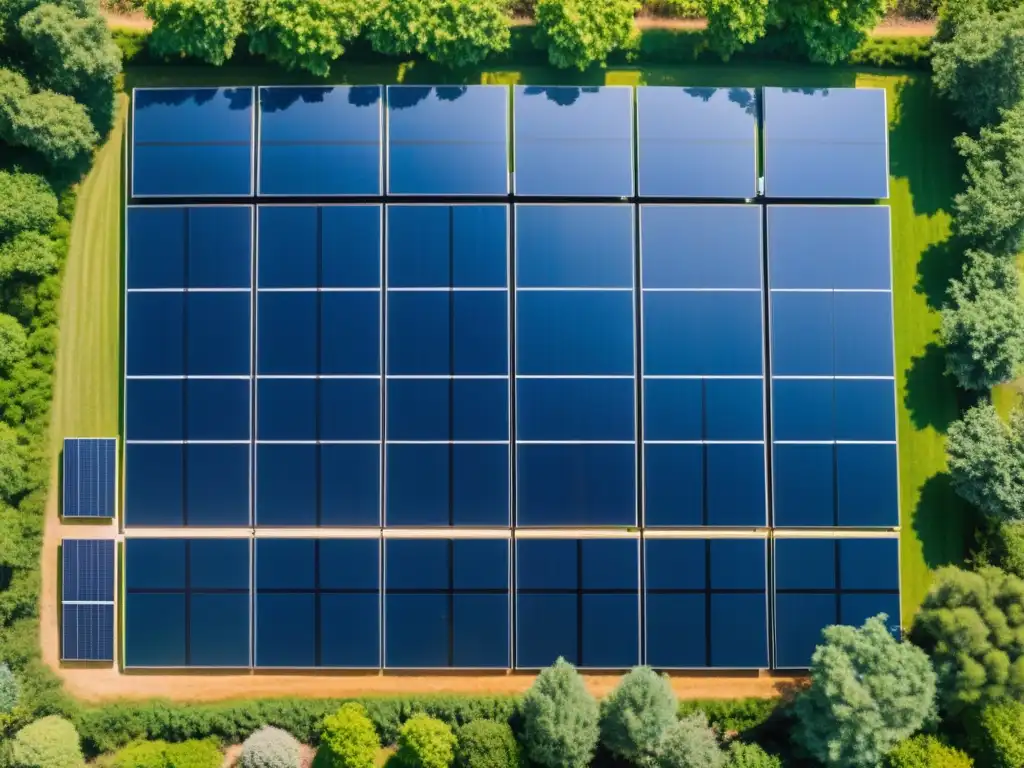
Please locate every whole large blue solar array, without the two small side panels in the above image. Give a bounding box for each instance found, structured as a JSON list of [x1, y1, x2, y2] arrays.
[[125, 86, 899, 669]]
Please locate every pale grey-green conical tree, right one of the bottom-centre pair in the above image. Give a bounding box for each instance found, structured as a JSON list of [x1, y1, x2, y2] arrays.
[[601, 667, 678, 767]]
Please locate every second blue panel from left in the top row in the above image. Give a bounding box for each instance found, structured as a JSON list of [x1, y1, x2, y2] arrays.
[[258, 85, 383, 196]]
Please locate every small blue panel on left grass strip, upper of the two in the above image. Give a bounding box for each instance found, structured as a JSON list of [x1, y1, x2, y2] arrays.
[[61, 437, 118, 517]]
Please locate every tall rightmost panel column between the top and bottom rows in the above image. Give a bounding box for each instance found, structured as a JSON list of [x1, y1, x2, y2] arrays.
[[768, 206, 899, 526]]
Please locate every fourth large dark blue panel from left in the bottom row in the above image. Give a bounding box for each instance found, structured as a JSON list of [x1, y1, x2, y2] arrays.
[[515, 539, 640, 669]]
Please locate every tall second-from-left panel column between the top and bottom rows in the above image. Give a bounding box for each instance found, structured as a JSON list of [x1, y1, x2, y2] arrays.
[[255, 205, 382, 526]]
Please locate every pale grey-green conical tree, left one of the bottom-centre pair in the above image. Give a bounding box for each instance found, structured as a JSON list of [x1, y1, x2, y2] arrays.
[[522, 658, 600, 768]]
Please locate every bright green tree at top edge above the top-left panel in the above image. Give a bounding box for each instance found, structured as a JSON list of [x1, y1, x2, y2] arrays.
[[145, 0, 245, 66]]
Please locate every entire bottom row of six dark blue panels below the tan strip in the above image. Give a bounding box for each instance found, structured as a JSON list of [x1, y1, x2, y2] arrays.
[[119, 539, 899, 669]]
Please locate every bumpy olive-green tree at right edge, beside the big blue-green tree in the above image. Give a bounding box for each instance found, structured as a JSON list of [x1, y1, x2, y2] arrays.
[[910, 566, 1024, 716]]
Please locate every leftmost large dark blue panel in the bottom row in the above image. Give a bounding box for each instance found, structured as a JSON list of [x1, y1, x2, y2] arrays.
[[124, 539, 251, 668]]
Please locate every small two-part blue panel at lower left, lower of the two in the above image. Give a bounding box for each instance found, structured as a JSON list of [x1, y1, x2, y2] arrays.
[[60, 539, 114, 662]]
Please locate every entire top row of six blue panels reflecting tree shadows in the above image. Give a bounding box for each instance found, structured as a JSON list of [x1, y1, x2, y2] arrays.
[[132, 85, 889, 200]]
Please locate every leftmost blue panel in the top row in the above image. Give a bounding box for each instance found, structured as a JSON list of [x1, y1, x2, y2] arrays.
[[132, 88, 255, 198]]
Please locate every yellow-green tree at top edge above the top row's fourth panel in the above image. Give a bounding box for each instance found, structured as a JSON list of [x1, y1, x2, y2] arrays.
[[534, 0, 640, 71]]
